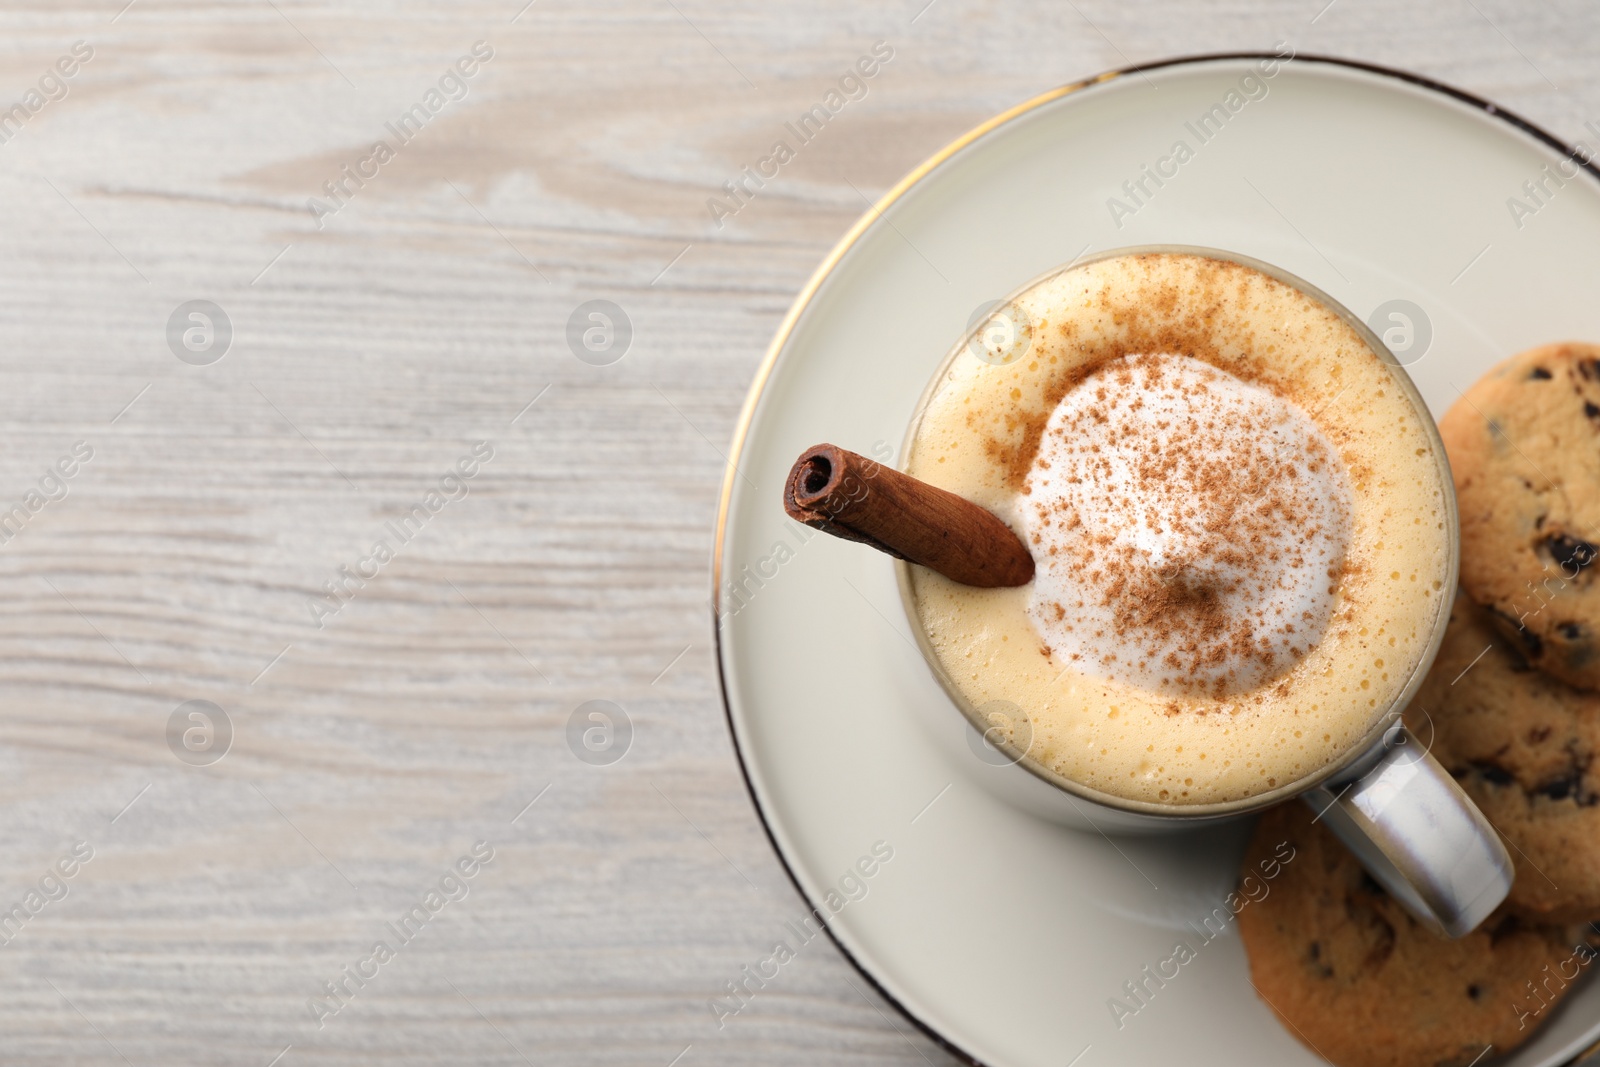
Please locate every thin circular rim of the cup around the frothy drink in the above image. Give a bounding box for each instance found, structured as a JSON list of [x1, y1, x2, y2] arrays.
[[894, 245, 1461, 819]]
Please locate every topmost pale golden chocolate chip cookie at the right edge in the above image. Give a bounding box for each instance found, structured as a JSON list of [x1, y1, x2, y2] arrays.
[[1438, 342, 1600, 689]]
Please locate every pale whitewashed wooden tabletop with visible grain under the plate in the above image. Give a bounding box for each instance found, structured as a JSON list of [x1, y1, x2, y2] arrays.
[[0, 0, 1600, 1067]]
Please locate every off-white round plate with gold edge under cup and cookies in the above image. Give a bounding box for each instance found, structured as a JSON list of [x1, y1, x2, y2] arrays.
[[717, 56, 1600, 1067]]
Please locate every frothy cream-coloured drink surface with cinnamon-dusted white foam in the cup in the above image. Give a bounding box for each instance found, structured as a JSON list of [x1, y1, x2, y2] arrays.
[[906, 253, 1450, 805]]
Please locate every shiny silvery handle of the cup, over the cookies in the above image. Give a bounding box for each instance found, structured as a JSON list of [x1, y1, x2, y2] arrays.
[[1302, 723, 1515, 937]]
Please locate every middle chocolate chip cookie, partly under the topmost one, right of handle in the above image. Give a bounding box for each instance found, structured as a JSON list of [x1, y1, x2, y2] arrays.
[[1405, 597, 1600, 921]]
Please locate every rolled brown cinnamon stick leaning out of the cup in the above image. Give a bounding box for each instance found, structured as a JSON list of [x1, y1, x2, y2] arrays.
[[784, 445, 1034, 589]]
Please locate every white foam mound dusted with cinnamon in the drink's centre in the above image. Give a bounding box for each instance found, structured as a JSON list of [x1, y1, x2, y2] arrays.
[[1021, 355, 1350, 696]]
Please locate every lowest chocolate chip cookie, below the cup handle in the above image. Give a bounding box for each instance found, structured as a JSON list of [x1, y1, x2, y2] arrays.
[[1238, 803, 1597, 1067]]
